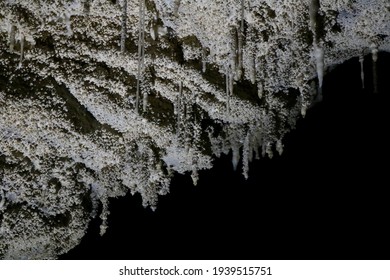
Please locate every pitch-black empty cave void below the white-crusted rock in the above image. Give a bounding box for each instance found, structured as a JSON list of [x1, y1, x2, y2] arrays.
[[60, 53, 390, 259]]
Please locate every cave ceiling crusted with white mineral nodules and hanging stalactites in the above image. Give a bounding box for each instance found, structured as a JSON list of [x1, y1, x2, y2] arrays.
[[0, 0, 390, 259]]
